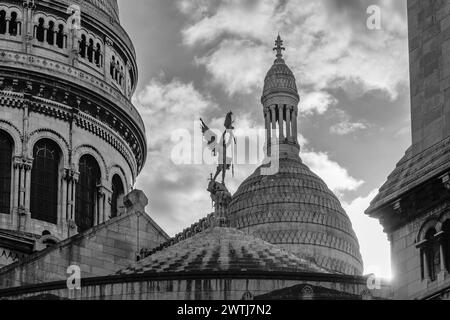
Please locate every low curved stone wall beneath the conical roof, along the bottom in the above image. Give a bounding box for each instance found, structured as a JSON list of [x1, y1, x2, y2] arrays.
[[0, 273, 389, 301]]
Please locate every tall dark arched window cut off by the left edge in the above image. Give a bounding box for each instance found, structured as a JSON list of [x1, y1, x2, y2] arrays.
[[0, 131, 13, 214]]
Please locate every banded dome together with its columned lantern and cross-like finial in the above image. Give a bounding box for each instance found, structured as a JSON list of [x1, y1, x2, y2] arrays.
[[229, 37, 363, 275]]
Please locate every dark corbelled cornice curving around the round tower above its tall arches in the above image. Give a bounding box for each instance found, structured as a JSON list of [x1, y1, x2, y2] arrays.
[[0, 68, 146, 177]]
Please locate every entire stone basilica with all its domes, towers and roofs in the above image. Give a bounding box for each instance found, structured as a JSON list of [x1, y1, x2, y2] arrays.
[[0, 0, 450, 300]]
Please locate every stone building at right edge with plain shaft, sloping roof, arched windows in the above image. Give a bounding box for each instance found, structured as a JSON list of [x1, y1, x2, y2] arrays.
[[366, 0, 450, 299]]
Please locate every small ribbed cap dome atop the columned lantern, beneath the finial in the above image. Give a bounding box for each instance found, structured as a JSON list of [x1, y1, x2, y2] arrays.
[[263, 60, 298, 96]]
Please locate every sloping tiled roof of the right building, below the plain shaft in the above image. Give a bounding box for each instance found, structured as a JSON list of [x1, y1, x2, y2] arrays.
[[366, 138, 450, 215]]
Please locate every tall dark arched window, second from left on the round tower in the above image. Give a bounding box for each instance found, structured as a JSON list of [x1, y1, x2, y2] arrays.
[[31, 139, 61, 224]]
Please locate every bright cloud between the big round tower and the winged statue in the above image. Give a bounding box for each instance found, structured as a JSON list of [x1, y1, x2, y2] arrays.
[[135, 79, 218, 235]]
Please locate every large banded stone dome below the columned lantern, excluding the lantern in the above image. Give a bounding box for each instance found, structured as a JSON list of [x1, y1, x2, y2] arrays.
[[229, 157, 363, 275]]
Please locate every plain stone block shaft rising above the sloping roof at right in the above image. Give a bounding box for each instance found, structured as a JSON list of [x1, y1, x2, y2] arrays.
[[408, 0, 450, 154]]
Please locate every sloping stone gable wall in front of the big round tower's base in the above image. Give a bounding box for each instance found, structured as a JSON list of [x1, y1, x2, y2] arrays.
[[0, 191, 168, 288]]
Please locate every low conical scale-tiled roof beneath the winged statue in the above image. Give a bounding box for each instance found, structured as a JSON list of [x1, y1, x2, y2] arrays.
[[119, 227, 329, 275]]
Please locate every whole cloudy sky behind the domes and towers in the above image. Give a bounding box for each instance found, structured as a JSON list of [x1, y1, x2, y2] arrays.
[[119, 0, 411, 277]]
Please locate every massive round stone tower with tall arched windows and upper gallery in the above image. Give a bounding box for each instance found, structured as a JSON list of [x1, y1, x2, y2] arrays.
[[0, 0, 147, 267]]
